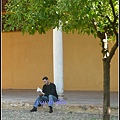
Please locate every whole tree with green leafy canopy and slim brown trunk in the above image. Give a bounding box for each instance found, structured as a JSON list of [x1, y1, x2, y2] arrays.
[[2, 0, 118, 120]]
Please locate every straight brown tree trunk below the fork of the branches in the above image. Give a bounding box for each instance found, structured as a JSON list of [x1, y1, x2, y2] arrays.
[[103, 58, 110, 120]]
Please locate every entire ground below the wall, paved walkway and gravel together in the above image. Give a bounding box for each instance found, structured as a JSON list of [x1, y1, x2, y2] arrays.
[[2, 89, 118, 120]]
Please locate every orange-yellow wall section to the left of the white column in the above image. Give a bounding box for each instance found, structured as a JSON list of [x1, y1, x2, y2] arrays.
[[2, 32, 53, 89]]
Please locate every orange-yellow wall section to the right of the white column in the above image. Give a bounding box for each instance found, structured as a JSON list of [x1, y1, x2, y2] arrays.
[[63, 34, 118, 91]]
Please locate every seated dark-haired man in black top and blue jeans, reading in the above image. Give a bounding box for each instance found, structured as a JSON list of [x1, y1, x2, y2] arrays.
[[30, 77, 58, 113]]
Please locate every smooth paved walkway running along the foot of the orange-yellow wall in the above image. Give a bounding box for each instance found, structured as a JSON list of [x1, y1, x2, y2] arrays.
[[2, 89, 118, 107]]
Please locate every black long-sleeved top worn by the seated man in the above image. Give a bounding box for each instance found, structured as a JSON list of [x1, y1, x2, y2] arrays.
[[42, 83, 58, 99]]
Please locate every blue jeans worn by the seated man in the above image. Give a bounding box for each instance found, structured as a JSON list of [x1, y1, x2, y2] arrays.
[[34, 95, 57, 108]]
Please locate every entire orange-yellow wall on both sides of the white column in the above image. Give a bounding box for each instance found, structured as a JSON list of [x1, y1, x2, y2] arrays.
[[2, 30, 118, 91]]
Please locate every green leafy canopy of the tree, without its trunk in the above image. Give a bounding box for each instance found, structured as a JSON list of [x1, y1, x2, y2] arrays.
[[2, 0, 118, 41]]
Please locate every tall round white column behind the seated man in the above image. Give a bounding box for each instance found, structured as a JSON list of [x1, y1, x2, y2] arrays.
[[53, 28, 63, 96]]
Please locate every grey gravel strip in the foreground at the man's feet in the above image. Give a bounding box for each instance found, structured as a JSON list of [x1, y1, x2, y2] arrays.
[[2, 107, 118, 120]]
